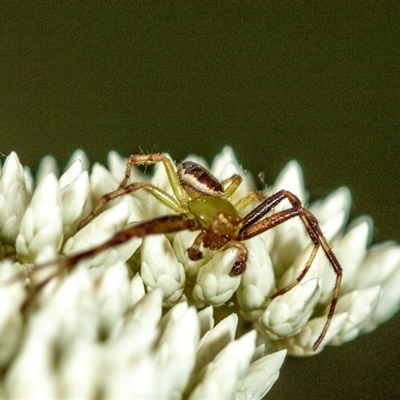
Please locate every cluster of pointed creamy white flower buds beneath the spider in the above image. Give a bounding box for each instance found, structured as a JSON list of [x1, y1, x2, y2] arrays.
[[0, 147, 400, 399]]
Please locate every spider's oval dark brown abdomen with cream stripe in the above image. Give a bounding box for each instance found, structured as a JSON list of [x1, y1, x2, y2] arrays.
[[177, 161, 224, 197]]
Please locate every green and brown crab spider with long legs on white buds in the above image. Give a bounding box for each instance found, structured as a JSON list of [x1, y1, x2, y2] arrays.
[[25, 153, 342, 351]]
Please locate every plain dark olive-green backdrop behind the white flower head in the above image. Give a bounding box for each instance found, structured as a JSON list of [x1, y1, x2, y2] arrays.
[[0, 1, 400, 399]]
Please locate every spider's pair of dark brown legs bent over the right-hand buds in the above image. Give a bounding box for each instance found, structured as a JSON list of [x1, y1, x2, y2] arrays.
[[237, 190, 342, 350]]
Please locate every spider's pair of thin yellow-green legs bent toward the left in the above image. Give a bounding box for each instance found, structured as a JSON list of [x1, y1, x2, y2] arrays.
[[78, 153, 186, 229]]
